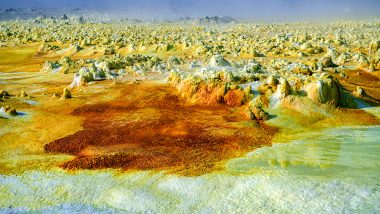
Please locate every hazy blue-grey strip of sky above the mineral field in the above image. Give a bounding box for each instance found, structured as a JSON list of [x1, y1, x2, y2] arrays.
[[0, 0, 380, 19]]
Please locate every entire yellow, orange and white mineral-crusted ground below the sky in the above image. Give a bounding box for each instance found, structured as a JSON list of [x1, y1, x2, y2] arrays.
[[0, 12, 380, 213]]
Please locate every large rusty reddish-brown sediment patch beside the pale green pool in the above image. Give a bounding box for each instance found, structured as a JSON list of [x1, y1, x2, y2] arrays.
[[45, 83, 276, 175]]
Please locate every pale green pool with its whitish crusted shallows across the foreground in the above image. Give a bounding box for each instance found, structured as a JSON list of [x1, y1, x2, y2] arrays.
[[0, 109, 380, 213]]
